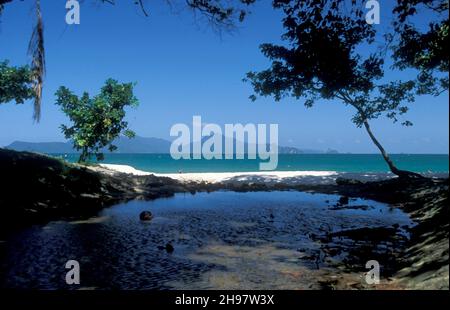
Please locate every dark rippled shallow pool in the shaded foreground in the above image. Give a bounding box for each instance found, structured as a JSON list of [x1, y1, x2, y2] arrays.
[[0, 191, 413, 289]]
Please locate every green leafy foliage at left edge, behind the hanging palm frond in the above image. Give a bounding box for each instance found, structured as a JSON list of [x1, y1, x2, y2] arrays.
[[0, 61, 33, 104]]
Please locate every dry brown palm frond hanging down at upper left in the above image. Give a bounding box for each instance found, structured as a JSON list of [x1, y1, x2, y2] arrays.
[[28, 0, 45, 122]]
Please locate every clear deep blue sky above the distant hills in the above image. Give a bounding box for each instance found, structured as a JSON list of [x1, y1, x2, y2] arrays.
[[0, 0, 449, 153]]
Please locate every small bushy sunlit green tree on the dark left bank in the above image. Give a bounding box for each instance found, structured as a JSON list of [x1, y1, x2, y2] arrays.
[[56, 79, 138, 162]]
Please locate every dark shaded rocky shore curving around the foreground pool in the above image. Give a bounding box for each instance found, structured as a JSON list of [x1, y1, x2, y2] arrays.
[[0, 149, 449, 289]]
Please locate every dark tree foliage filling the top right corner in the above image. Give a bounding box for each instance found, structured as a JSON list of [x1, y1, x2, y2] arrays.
[[393, 0, 450, 95]]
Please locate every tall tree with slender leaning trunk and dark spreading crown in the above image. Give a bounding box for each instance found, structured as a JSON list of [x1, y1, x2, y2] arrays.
[[245, 0, 448, 177]]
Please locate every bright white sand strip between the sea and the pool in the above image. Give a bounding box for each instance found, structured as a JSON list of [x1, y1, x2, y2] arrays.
[[101, 164, 338, 183]]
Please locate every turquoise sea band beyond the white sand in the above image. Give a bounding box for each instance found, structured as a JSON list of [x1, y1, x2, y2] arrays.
[[57, 154, 449, 173]]
